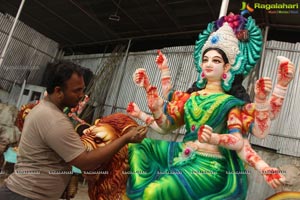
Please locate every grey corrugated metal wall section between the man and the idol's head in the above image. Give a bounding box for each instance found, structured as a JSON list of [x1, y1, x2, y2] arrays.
[[65, 46, 197, 114]]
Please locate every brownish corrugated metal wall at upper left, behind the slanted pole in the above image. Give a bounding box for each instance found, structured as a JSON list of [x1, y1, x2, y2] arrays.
[[0, 13, 59, 91]]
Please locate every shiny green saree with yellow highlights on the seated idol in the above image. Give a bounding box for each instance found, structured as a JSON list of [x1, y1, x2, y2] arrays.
[[127, 93, 247, 200]]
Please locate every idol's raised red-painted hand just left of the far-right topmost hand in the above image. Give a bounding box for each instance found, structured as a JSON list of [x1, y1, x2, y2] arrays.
[[254, 77, 272, 102]]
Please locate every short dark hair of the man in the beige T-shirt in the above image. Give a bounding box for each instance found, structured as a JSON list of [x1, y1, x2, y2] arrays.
[[45, 60, 83, 94]]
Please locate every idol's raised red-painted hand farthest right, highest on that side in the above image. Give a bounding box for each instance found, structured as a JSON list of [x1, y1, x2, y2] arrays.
[[277, 56, 295, 87]]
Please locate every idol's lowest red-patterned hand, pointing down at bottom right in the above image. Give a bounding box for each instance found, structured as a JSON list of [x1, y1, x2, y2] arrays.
[[262, 167, 285, 189]]
